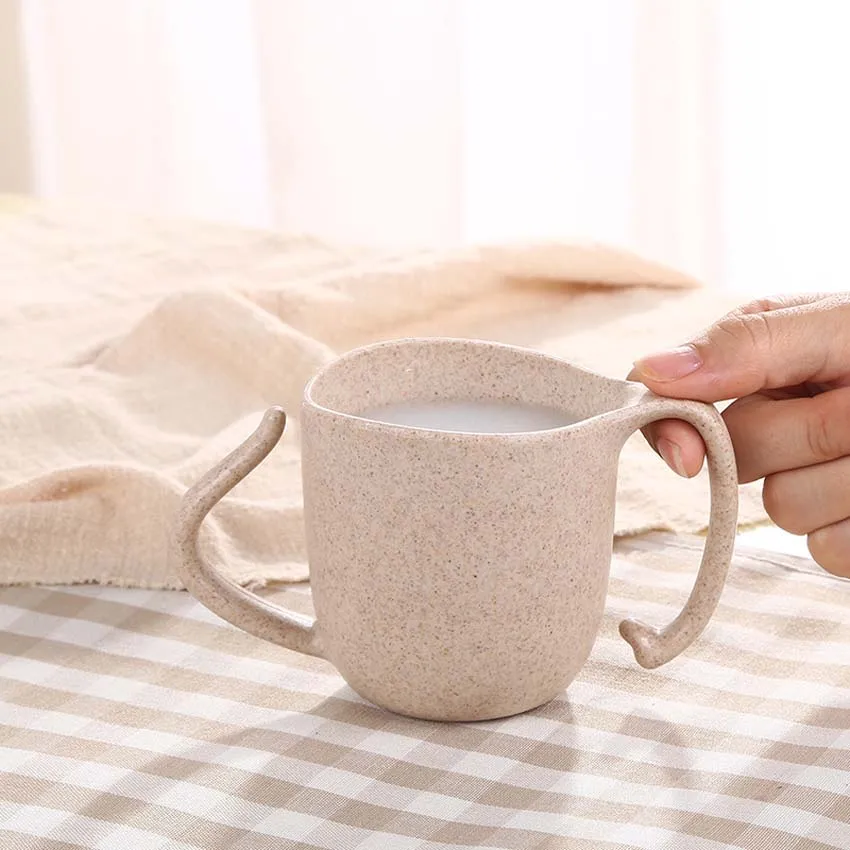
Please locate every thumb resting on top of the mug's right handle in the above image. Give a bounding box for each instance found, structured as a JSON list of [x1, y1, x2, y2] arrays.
[[632, 295, 850, 402]]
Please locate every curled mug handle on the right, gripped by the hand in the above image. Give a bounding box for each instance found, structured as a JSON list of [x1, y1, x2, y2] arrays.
[[608, 393, 738, 669]]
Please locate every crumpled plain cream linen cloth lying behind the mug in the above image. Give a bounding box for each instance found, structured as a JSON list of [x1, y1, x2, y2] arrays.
[[0, 198, 765, 588]]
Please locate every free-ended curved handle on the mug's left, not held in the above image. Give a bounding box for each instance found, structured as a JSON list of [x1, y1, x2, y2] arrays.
[[173, 407, 322, 657]]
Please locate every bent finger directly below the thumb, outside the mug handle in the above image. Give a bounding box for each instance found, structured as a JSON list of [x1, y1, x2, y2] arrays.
[[723, 387, 850, 483]]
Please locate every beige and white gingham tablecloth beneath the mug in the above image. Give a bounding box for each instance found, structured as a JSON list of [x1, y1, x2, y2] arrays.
[[0, 539, 850, 850]]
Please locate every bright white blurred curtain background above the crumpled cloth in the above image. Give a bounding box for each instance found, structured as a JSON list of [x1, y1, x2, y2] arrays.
[[0, 0, 850, 293]]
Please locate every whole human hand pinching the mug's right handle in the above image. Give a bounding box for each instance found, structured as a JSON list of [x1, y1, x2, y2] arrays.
[[629, 294, 850, 577]]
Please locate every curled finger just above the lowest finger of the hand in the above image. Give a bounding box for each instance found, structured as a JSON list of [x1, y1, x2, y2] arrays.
[[763, 457, 850, 534]]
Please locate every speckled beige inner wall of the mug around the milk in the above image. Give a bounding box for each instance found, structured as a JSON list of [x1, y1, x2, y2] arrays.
[[305, 338, 628, 432]]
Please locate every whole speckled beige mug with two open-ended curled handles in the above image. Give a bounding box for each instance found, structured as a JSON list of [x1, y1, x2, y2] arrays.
[[176, 339, 738, 721]]
